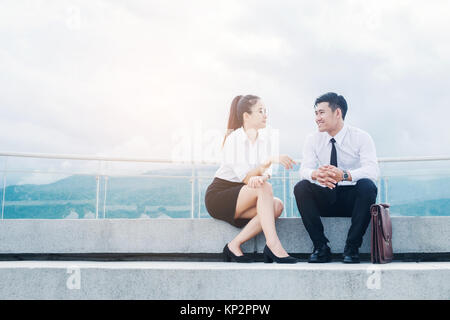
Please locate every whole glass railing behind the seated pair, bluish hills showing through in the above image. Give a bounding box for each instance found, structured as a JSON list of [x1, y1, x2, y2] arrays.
[[0, 154, 450, 219]]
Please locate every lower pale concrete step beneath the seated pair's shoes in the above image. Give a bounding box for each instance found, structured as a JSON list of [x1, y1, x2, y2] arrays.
[[0, 261, 450, 300]]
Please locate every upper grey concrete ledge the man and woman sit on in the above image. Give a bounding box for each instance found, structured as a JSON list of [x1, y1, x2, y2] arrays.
[[0, 217, 450, 254]]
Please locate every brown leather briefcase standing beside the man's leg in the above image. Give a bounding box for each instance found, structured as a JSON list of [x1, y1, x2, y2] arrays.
[[370, 203, 394, 263]]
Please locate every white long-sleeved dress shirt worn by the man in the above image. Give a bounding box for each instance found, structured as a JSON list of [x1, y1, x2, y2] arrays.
[[300, 125, 380, 186]]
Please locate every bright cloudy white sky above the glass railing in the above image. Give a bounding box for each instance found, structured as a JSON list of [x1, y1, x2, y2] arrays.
[[0, 0, 450, 165]]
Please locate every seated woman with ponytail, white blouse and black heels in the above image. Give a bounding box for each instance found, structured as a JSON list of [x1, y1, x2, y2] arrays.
[[205, 95, 297, 263]]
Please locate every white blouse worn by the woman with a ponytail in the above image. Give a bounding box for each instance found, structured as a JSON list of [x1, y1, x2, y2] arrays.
[[214, 127, 278, 182]]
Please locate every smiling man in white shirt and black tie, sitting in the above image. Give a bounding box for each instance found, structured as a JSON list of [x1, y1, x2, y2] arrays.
[[294, 92, 379, 263]]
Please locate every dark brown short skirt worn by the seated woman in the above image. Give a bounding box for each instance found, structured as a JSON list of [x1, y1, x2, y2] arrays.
[[205, 177, 250, 228]]
